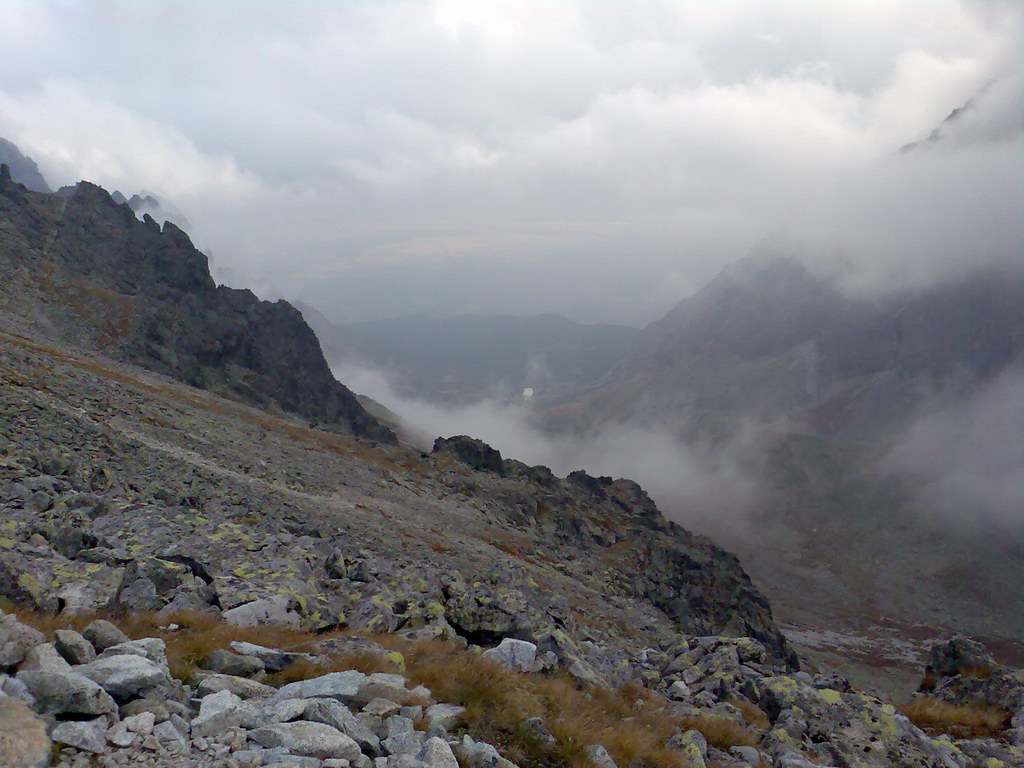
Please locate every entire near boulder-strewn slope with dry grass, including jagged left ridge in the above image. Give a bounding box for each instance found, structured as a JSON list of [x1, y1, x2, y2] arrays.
[[0, 150, 1024, 768]]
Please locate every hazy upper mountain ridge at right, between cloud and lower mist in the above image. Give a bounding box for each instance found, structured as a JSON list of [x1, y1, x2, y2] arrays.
[[569, 253, 1024, 438]]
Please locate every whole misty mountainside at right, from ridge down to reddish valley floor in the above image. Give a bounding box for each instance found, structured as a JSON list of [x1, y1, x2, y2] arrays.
[[546, 258, 1024, 682]]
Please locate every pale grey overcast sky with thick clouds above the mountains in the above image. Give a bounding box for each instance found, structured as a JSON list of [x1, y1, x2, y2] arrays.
[[0, 0, 1024, 324]]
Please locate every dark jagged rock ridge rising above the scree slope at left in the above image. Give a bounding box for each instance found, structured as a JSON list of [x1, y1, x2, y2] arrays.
[[0, 165, 394, 442]]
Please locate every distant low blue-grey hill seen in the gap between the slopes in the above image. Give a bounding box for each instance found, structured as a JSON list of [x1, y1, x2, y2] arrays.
[[310, 314, 640, 403]]
